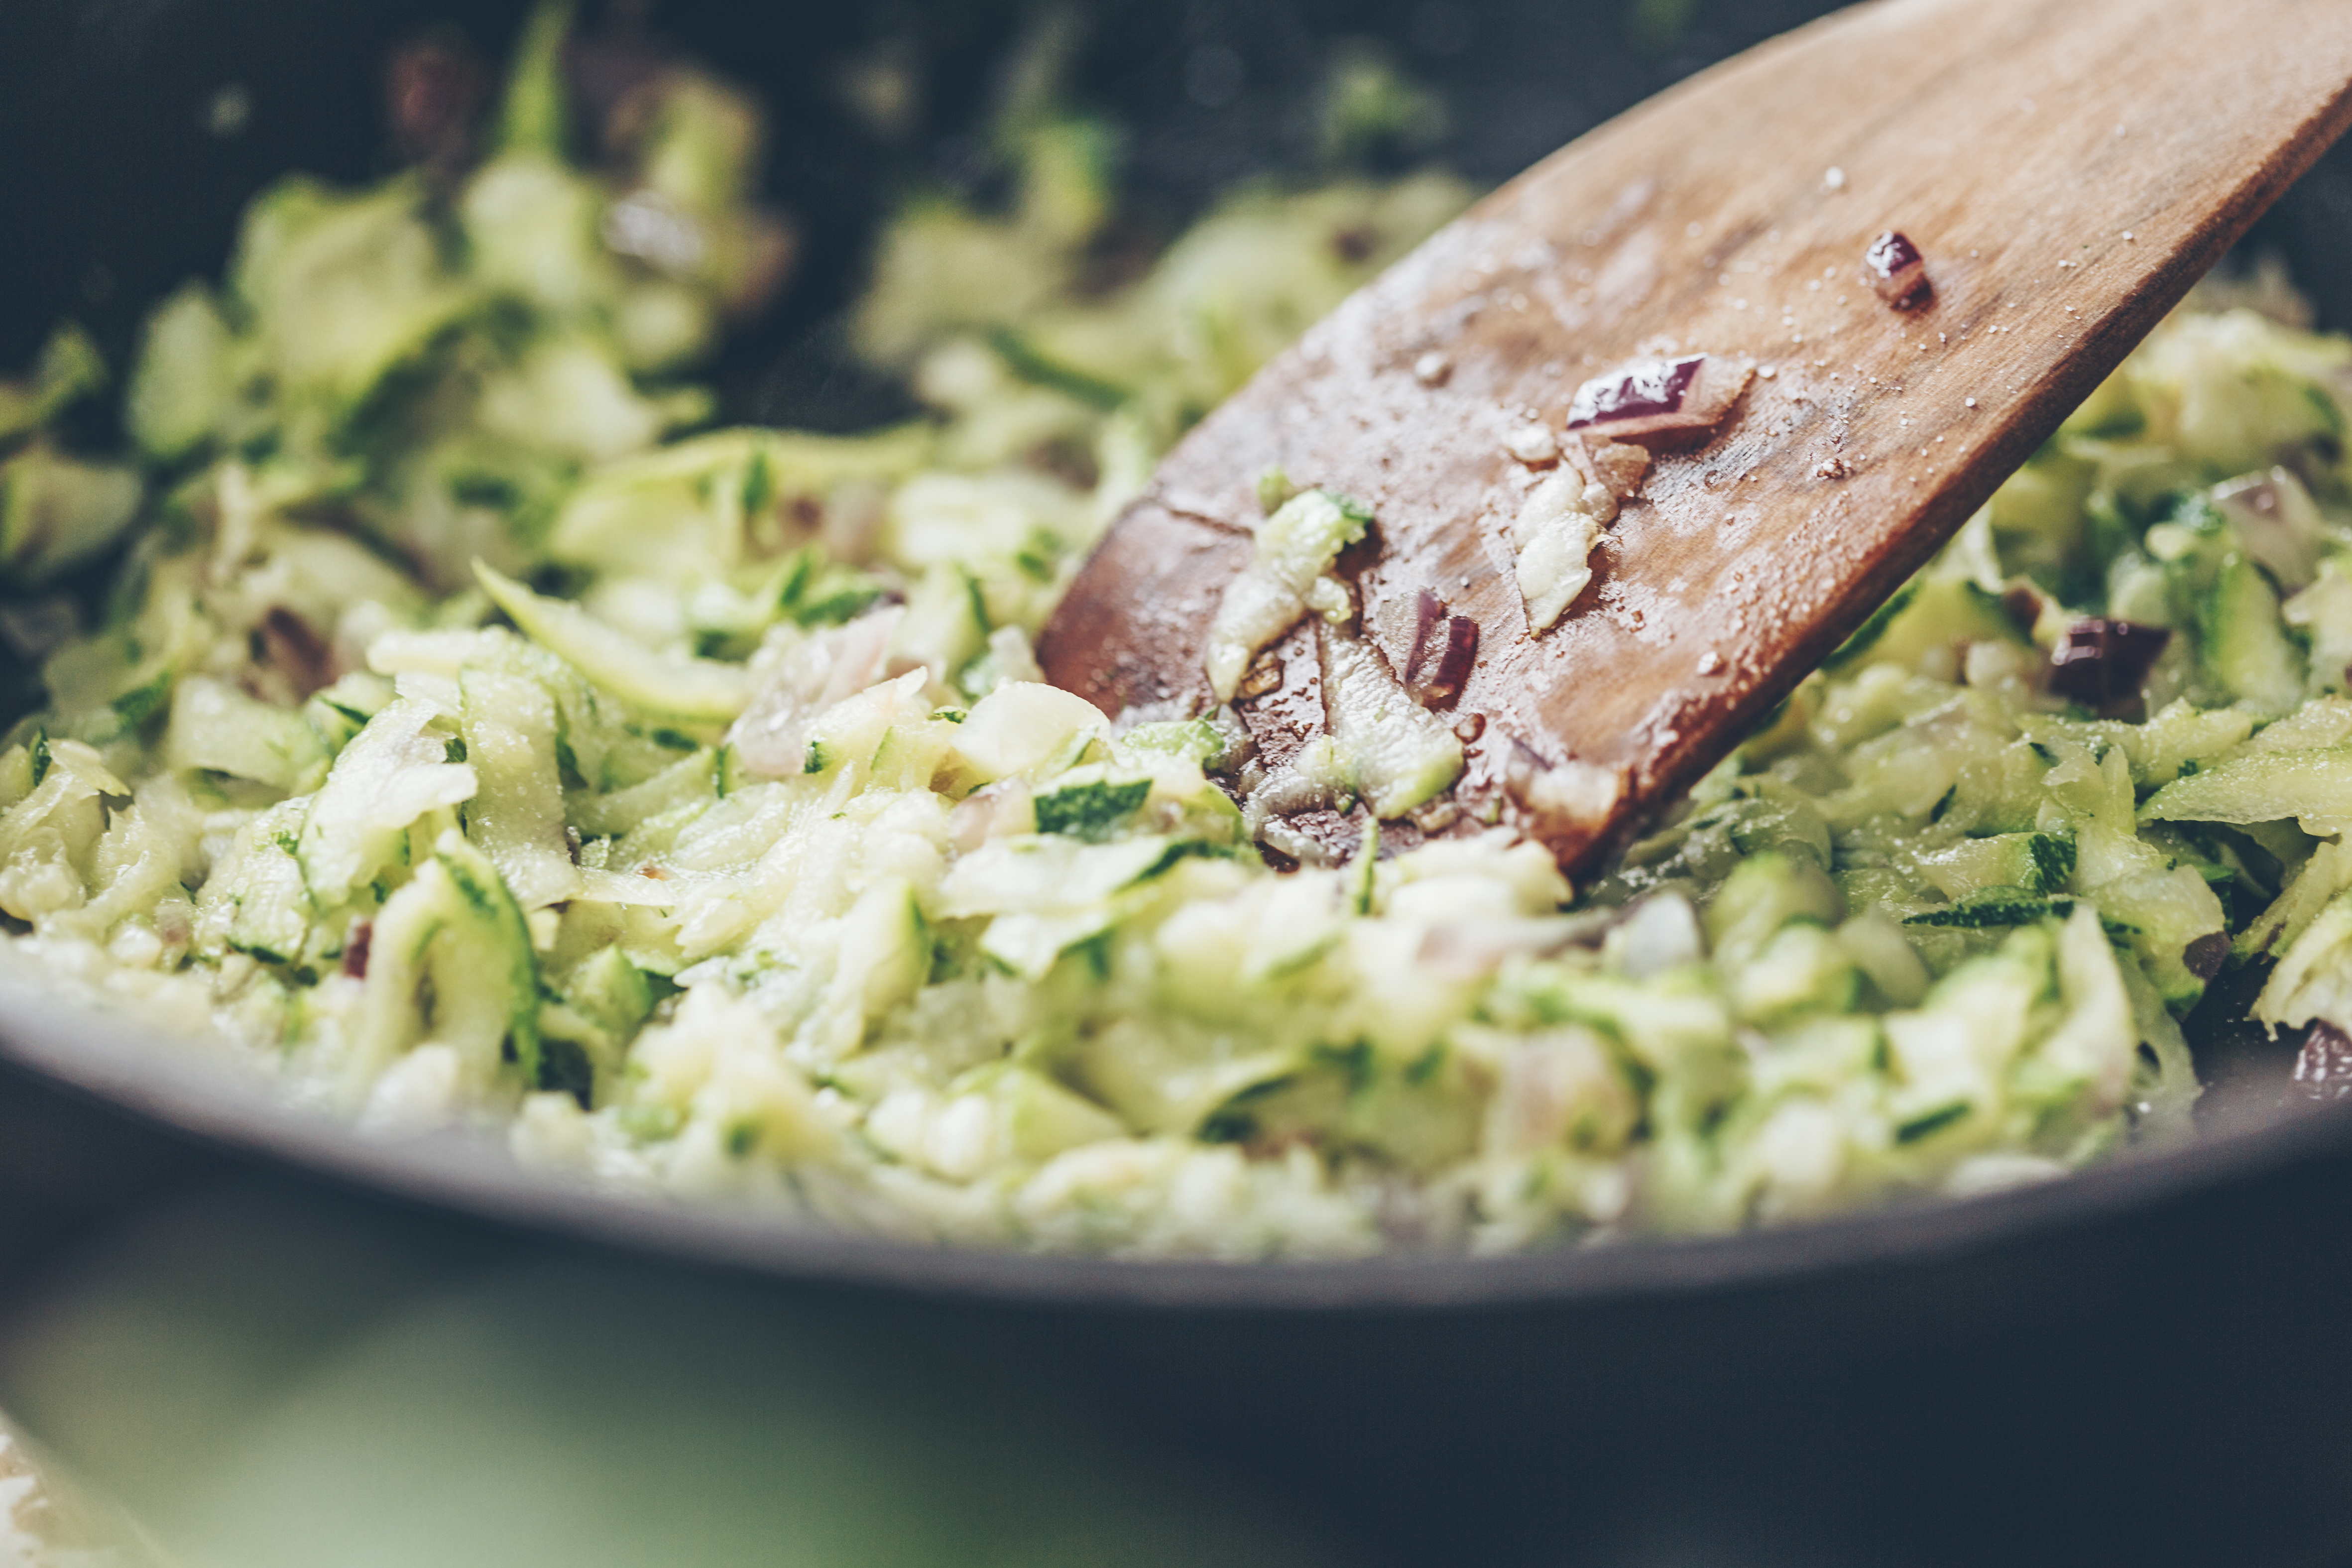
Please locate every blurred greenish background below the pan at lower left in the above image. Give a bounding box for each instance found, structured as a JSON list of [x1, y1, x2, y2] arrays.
[[0, 1082, 1357, 1568]]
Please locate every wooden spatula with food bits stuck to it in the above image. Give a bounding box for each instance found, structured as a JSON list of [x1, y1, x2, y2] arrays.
[[1040, 0, 2352, 870]]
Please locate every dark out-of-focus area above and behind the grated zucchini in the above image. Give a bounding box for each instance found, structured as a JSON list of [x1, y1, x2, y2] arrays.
[[18, 0, 2352, 428]]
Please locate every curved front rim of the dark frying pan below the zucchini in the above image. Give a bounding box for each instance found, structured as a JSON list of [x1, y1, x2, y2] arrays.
[[0, 966, 2352, 1317]]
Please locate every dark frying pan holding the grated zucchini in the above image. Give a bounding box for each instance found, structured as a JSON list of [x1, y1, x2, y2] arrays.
[[0, 0, 2352, 1566]]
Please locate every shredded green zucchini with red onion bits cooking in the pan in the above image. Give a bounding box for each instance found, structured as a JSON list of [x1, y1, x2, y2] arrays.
[[0, 19, 2352, 1258]]
